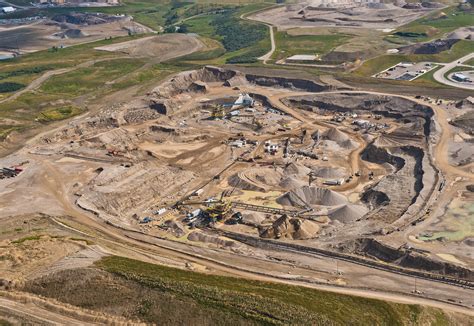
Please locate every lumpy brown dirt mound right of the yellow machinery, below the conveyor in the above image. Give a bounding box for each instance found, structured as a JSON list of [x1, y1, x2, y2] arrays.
[[260, 215, 319, 240]]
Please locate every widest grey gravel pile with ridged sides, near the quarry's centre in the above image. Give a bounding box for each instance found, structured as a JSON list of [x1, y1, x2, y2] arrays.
[[277, 186, 347, 207]]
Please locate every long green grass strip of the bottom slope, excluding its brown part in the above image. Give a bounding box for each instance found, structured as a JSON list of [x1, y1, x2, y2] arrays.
[[90, 257, 462, 325]]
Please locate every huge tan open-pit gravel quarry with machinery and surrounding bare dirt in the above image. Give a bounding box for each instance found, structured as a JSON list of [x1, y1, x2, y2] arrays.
[[0, 65, 474, 322]]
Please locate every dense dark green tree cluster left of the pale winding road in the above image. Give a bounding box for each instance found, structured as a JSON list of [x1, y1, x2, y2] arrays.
[[211, 10, 268, 52]]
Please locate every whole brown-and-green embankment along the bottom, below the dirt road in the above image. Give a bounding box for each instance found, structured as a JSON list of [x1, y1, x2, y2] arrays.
[[24, 256, 467, 325]]
